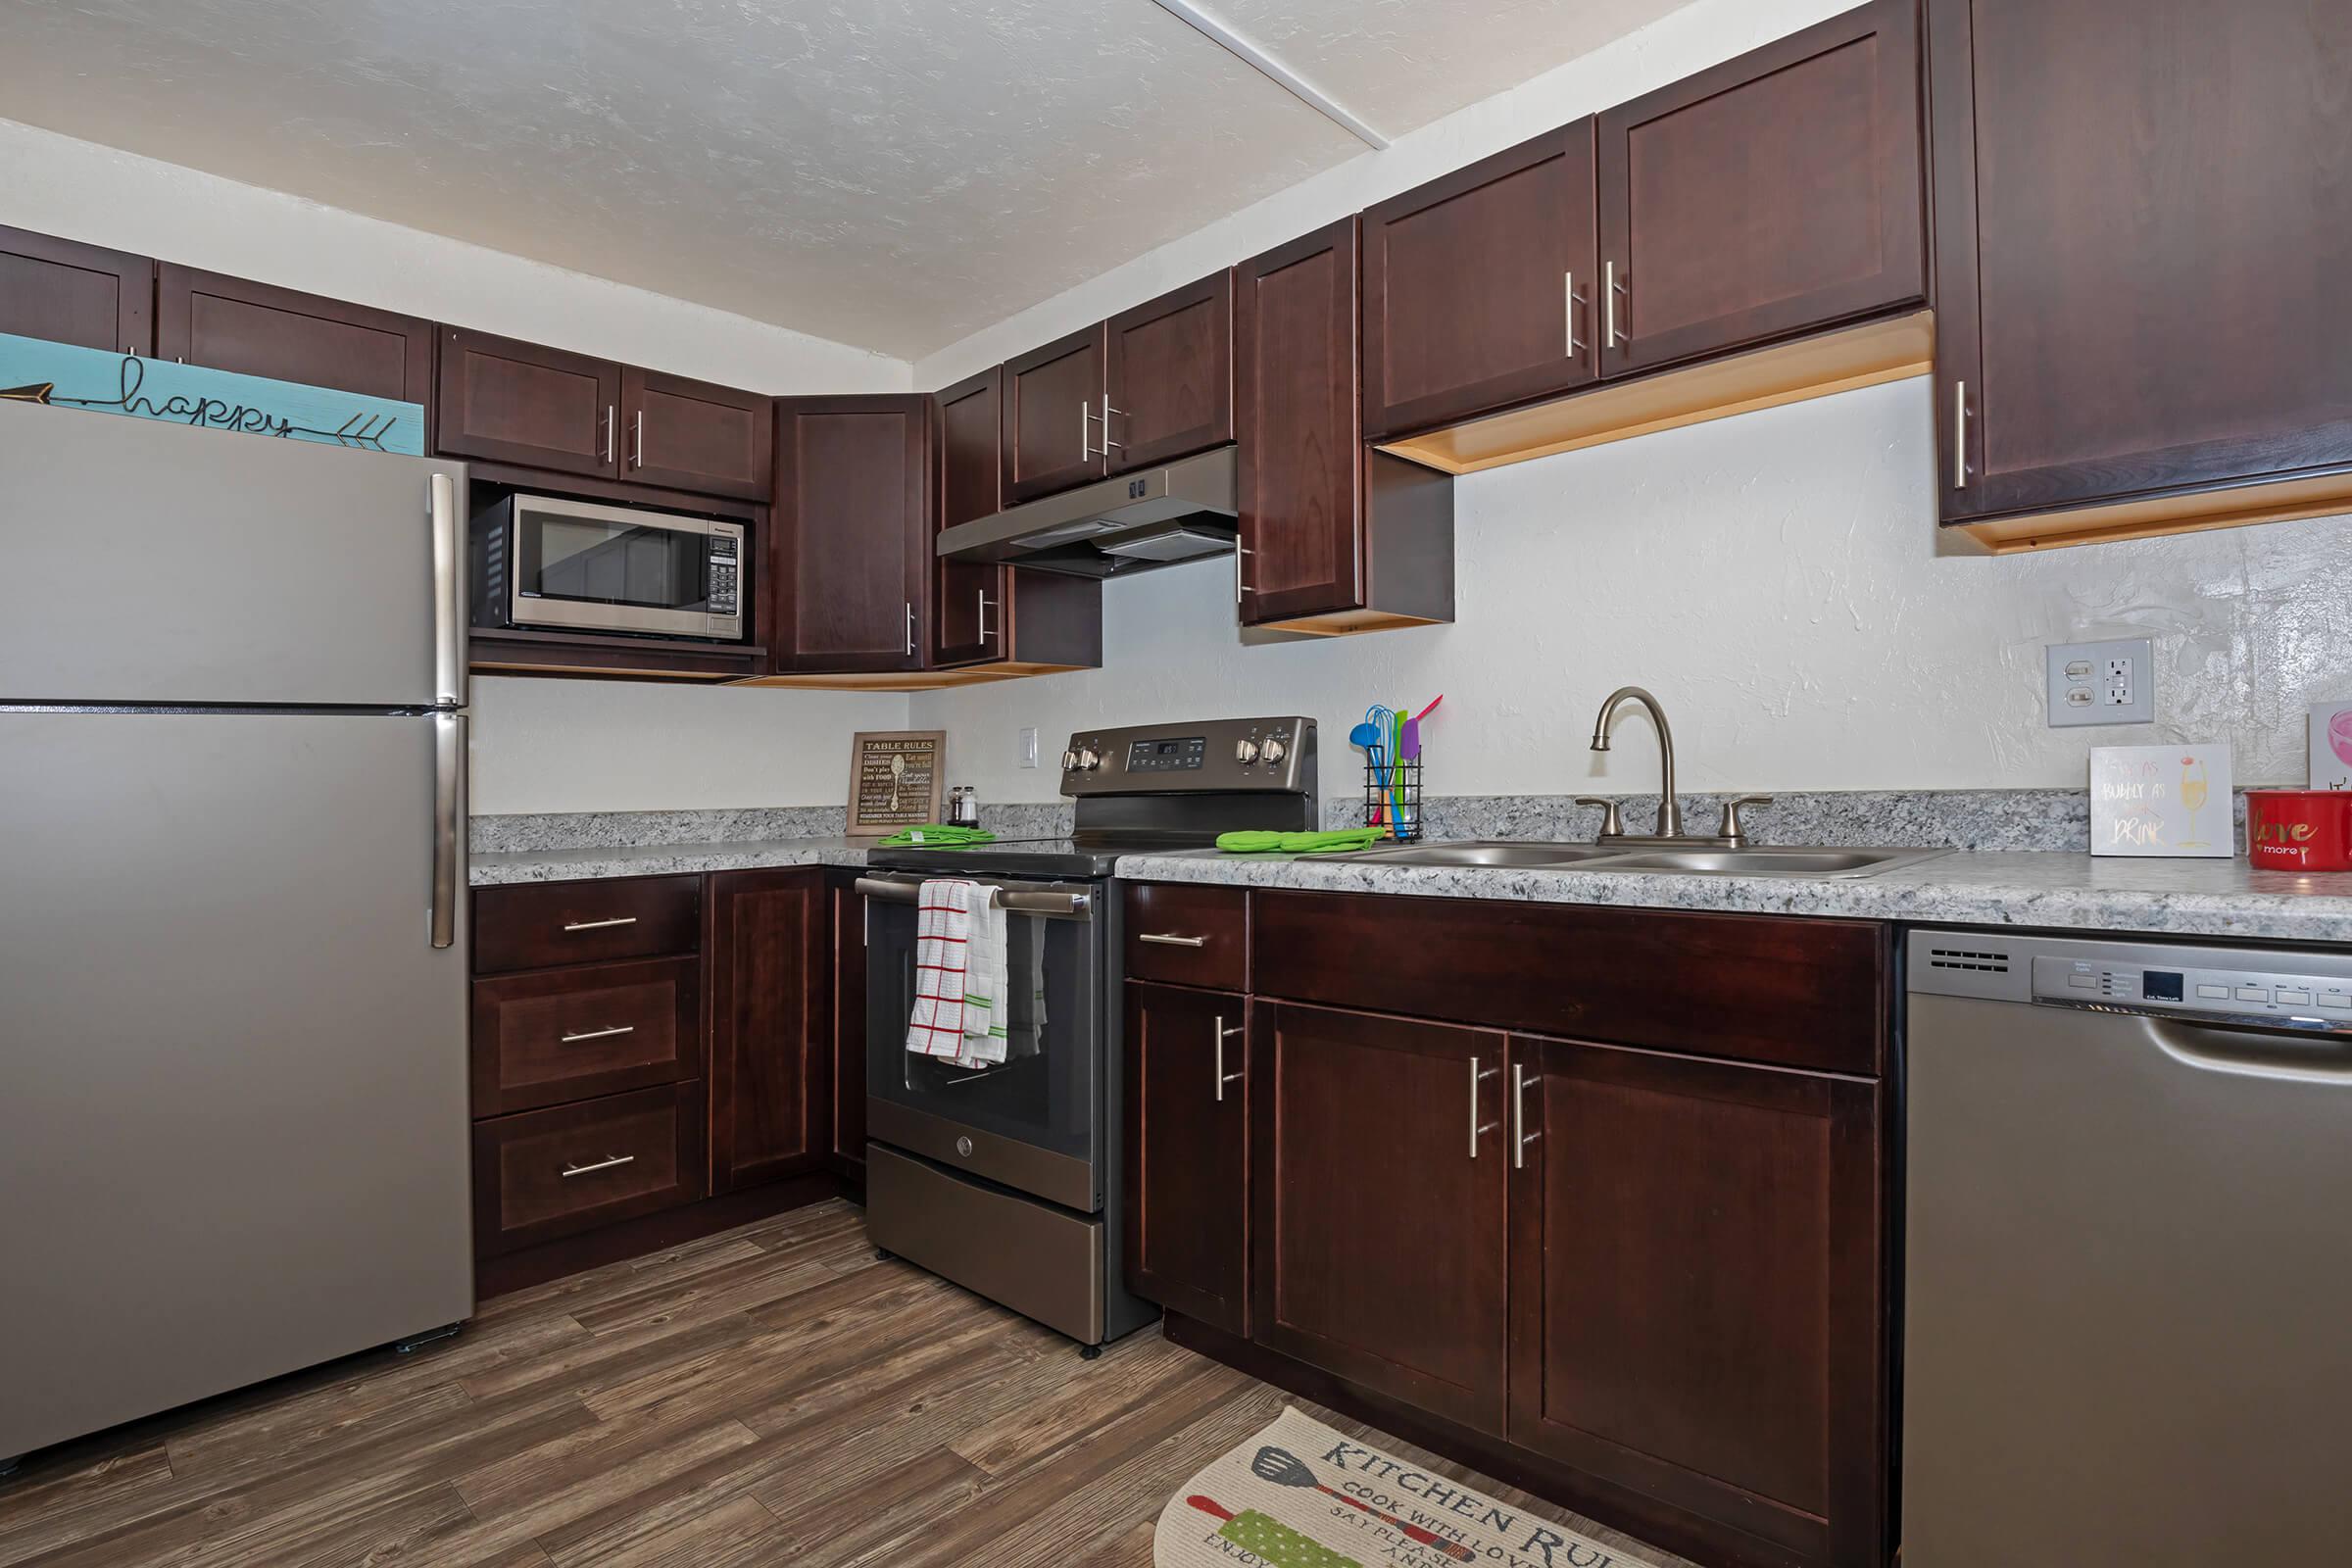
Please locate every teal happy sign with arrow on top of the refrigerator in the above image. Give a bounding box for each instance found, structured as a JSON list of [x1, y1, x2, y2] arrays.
[[0, 331, 425, 456]]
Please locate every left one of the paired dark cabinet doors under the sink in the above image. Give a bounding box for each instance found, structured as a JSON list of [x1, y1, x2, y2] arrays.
[[1249, 1002, 1510, 1432]]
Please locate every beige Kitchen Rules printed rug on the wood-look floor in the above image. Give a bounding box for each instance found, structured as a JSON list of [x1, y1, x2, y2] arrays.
[[1152, 1408, 1653, 1568]]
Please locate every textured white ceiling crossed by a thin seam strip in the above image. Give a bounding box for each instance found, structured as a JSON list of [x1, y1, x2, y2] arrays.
[[0, 0, 1684, 358]]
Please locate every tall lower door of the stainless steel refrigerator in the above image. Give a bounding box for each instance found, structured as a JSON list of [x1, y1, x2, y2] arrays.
[[0, 710, 472, 1457]]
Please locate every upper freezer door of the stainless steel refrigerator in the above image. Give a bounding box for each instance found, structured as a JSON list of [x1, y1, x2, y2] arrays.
[[0, 402, 466, 708]]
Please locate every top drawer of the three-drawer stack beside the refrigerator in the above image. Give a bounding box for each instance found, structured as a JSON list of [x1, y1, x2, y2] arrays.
[[472, 877, 704, 976]]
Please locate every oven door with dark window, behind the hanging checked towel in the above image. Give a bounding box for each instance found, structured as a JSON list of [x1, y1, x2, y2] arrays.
[[858, 874, 1110, 1213]]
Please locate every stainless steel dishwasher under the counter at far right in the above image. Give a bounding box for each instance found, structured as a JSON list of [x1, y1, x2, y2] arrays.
[[1903, 931, 2352, 1568]]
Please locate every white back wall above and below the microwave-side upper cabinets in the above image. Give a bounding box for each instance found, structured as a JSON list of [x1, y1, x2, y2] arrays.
[[0, 120, 910, 813]]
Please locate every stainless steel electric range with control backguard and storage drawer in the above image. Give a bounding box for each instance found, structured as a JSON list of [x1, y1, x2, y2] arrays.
[[857, 717, 1317, 1354]]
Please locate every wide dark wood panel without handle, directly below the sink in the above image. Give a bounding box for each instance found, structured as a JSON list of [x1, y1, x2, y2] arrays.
[[1251, 891, 1893, 1077]]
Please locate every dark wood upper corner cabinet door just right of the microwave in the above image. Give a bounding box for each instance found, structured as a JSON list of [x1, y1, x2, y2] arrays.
[[766, 393, 931, 674]]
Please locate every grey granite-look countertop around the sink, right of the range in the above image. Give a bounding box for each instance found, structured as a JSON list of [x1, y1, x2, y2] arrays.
[[1119, 851, 2352, 943]]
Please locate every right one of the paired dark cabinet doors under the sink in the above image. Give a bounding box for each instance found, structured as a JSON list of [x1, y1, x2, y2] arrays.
[[1498, 1037, 1886, 1566]]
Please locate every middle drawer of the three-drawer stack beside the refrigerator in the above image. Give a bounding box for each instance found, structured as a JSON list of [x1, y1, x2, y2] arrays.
[[472, 959, 701, 1116]]
